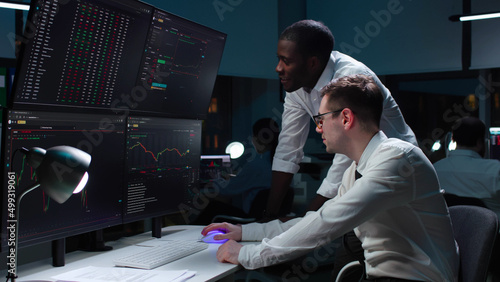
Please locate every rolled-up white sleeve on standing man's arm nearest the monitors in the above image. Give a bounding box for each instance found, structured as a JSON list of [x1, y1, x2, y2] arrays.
[[272, 93, 311, 173]]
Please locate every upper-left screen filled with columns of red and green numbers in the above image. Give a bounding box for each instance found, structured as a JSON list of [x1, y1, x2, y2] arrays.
[[14, 0, 153, 112]]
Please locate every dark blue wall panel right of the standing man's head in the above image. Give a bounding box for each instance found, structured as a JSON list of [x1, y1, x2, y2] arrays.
[[307, 0, 462, 75]]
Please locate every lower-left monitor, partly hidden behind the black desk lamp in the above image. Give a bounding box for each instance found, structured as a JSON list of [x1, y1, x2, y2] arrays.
[[1, 110, 125, 246]]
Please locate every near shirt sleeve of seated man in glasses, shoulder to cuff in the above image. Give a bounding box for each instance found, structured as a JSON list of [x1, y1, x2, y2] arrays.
[[238, 145, 414, 269]]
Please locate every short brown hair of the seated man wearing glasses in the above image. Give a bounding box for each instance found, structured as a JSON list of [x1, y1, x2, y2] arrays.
[[322, 74, 384, 129]]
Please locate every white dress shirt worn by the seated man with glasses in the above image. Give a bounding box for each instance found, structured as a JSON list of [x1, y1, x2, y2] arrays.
[[238, 131, 459, 281]]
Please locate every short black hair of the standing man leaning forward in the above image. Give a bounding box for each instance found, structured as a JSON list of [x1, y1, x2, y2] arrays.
[[279, 20, 335, 62]]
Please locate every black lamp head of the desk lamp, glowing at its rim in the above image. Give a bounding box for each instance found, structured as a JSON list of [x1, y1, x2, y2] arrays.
[[23, 146, 91, 204]]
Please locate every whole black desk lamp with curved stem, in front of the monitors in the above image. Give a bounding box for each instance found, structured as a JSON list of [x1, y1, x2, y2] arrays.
[[7, 146, 91, 282]]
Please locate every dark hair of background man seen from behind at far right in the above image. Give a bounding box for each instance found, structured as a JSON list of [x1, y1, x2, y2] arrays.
[[452, 117, 486, 147]]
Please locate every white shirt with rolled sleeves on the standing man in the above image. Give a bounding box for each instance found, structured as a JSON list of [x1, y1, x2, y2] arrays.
[[273, 51, 417, 198]]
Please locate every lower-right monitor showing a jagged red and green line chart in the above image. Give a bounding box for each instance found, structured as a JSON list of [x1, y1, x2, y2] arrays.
[[123, 116, 201, 223]]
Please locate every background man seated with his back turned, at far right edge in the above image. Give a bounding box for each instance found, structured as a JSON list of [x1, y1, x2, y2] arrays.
[[434, 117, 500, 218]]
